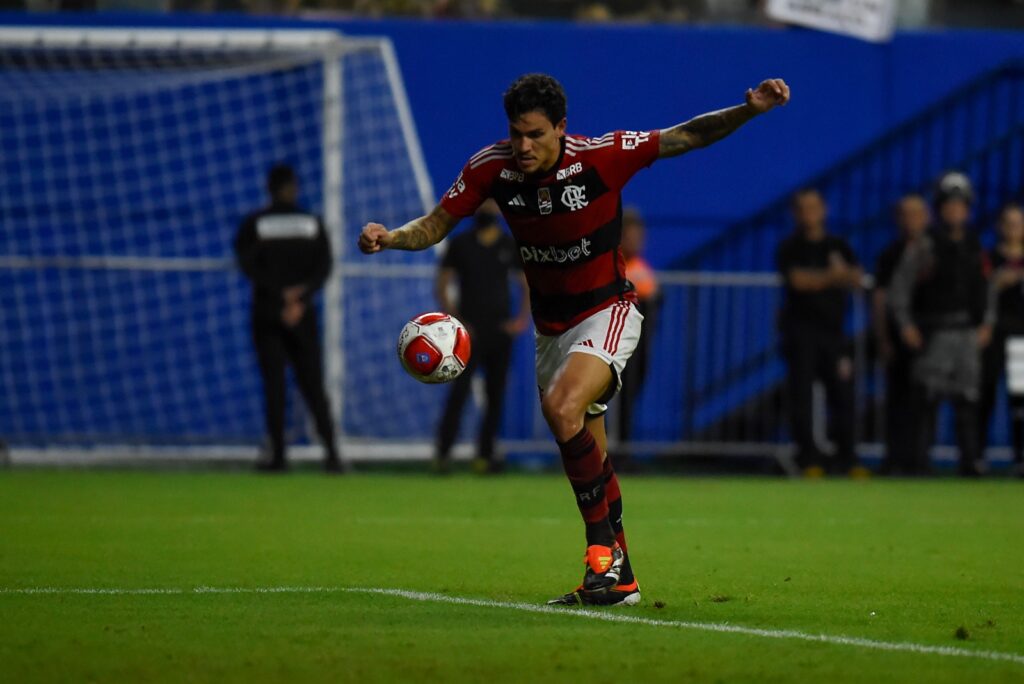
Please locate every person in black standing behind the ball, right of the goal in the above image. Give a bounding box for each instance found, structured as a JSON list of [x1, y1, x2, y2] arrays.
[[434, 201, 529, 473]]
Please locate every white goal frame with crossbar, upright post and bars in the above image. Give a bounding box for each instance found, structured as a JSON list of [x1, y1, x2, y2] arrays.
[[0, 27, 435, 464]]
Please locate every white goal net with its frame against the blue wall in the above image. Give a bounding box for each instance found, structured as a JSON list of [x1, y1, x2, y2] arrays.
[[0, 29, 437, 453]]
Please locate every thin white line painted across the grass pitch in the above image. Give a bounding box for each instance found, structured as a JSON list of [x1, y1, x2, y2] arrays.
[[0, 587, 1024, 665]]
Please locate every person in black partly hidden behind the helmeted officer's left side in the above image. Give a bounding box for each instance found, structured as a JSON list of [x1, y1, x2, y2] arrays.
[[871, 194, 932, 475]]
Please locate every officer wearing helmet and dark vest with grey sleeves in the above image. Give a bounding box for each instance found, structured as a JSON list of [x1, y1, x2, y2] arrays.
[[890, 172, 993, 476]]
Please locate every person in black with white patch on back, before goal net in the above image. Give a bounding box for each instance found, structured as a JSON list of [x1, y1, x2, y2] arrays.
[[234, 164, 342, 472]]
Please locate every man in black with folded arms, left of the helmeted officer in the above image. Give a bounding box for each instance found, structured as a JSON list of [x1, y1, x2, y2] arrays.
[[776, 188, 867, 477]]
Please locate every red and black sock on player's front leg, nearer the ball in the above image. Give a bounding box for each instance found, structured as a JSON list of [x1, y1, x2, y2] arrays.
[[558, 428, 615, 547]]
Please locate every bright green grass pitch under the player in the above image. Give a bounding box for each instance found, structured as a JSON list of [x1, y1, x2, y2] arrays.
[[0, 470, 1024, 684]]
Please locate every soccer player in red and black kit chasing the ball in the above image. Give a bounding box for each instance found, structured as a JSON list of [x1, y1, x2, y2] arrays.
[[358, 74, 790, 605]]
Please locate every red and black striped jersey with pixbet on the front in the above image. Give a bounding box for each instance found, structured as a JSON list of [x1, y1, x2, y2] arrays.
[[441, 131, 658, 335]]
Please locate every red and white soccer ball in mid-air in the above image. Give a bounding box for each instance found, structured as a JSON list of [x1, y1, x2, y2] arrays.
[[398, 313, 469, 384]]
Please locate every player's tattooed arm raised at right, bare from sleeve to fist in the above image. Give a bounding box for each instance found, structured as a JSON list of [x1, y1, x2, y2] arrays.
[[657, 79, 790, 159]]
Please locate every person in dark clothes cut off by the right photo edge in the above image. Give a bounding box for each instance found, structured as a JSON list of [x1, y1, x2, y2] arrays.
[[978, 204, 1024, 477]]
